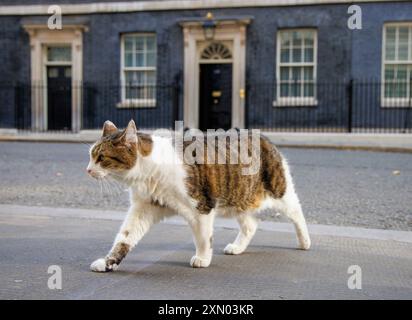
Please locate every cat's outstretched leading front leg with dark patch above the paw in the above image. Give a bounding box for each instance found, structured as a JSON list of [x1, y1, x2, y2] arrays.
[[90, 204, 163, 272]]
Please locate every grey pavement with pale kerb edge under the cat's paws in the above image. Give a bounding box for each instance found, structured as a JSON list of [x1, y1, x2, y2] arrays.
[[0, 206, 412, 299]]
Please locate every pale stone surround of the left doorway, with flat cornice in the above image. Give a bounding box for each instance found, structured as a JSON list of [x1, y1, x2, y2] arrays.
[[24, 25, 87, 132]]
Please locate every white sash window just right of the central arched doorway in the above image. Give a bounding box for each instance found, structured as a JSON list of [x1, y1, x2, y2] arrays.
[[274, 29, 317, 106]]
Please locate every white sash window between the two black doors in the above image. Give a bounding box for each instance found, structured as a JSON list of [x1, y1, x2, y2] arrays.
[[118, 34, 156, 107]]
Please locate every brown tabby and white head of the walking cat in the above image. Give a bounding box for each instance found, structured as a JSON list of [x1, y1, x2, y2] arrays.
[[87, 120, 150, 179]]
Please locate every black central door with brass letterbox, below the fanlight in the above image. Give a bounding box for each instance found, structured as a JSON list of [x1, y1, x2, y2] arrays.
[[199, 63, 232, 130]]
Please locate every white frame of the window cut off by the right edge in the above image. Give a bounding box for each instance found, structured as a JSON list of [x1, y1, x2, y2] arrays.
[[381, 22, 412, 108]]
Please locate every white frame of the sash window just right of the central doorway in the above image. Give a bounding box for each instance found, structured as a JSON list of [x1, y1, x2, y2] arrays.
[[273, 28, 318, 107]]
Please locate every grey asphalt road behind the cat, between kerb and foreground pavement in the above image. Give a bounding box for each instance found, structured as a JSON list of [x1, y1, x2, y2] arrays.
[[0, 142, 412, 231]]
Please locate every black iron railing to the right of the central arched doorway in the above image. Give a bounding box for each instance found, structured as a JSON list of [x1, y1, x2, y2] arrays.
[[246, 80, 412, 133]]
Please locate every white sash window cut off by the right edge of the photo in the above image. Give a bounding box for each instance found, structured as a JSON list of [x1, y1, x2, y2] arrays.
[[382, 23, 412, 107]]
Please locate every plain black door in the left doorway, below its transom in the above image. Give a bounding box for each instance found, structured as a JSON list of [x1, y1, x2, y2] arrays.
[[47, 66, 72, 130]]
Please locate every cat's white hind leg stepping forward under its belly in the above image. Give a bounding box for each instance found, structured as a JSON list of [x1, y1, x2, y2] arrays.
[[223, 213, 258, 254]]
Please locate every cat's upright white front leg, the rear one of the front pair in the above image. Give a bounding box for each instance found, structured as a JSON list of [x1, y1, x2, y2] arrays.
[[189, 210, 215, 268]]
